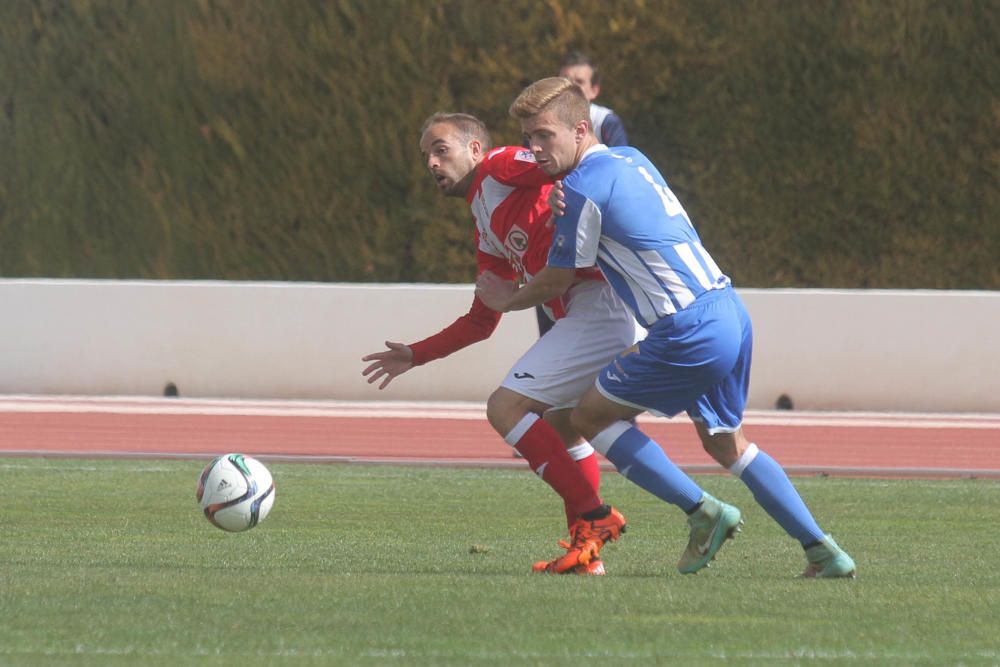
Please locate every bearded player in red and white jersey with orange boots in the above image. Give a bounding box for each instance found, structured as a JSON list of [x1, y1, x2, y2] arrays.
[[362, 113, 639, 574]]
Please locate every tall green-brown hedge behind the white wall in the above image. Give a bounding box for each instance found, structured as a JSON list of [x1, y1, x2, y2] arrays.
[[0, 0, 1000, 289]]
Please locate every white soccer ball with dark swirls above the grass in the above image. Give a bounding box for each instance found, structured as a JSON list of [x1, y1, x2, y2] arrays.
[[198, 454, 274, 533]]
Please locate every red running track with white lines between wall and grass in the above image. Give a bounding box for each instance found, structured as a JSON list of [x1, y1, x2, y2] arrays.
[[0, 397, 1000, 479]]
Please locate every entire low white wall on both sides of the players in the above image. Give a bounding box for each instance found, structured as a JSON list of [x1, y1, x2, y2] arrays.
[[0, 280, 1000, 412]]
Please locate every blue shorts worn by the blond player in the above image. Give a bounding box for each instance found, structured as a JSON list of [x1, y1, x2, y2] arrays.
[[597, 288, 753, 433]]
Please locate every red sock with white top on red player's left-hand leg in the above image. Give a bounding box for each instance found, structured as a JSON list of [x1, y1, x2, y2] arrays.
[[504, 413, 602, 514]]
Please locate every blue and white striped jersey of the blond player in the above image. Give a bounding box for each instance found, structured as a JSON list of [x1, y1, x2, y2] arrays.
[[548, 144, 730, 329]]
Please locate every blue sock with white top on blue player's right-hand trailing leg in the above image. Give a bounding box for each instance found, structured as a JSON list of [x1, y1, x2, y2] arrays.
[[733, 444, 823, 546]]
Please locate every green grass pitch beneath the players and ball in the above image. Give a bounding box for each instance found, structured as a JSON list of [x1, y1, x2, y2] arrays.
[[0, 459, 1000, 665]]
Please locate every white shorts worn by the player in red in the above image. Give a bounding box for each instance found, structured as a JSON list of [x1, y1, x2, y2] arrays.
[[500, 280, 645, 408]]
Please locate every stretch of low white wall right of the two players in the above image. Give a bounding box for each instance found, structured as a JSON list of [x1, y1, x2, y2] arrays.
[[740, 289, 1000, 412]]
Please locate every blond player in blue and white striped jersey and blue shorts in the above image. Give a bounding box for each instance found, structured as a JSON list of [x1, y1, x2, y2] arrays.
[[477, 77, 855, 577]]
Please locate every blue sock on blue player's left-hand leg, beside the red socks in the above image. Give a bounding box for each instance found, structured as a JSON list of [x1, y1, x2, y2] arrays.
[[591, 422, 703, 512]]
